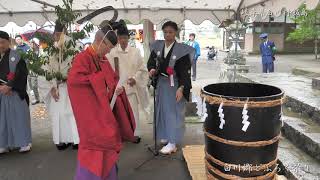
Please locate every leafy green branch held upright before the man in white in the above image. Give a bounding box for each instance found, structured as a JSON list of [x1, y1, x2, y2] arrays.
[[23, 0, 93, 81]]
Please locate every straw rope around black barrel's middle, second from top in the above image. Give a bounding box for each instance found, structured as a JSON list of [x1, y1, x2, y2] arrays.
[[203, 129, 281, 147]]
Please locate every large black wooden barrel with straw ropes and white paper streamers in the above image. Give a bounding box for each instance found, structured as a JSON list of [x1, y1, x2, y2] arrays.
[[201, 83, 284, 180]]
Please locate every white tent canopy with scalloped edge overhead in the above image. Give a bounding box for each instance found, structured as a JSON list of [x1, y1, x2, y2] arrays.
[[0, 0, 320, 26]]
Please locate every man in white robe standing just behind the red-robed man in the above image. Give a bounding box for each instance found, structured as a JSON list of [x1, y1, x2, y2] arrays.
[[107, 24, 149, 143]]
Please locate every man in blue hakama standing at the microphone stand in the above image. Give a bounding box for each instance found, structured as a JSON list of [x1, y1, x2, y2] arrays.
[[148, 21, 194, 154]]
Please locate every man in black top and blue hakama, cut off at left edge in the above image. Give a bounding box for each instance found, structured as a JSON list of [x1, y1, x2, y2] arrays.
[[0, 31, 31, 154]]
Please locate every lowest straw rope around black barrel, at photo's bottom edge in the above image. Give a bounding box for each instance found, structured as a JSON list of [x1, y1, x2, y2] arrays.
[[205, 160, 277, 180]]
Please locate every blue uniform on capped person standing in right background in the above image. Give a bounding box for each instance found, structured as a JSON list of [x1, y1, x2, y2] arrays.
[[260, 41, 275, 73]]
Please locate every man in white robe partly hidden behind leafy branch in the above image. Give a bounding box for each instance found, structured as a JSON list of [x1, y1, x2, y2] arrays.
[[45, 22, 79, 150]]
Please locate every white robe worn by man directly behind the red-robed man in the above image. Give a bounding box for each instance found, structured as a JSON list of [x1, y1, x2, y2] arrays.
[[107, 45, 150, 135]]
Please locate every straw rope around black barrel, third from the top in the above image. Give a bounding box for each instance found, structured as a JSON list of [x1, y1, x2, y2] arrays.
[[206, 152, 278, 172]]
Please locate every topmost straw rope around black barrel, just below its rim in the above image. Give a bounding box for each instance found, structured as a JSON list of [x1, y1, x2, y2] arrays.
[[200, 92, 286, 108]]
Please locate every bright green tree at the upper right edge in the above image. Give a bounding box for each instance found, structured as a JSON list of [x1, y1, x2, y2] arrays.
[[287, 4, 320, 59]]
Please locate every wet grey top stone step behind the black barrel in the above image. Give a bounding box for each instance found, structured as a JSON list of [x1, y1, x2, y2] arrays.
[[237, 73, 320, 125]]
